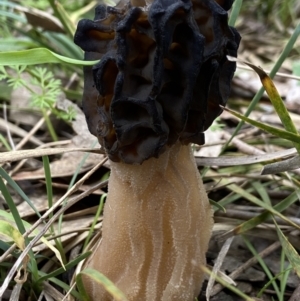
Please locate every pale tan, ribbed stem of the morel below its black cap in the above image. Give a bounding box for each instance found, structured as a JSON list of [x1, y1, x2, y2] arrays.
[[84, 143, 213, 301]]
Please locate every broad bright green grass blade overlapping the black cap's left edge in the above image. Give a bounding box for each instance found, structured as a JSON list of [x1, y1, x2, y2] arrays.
[[0, 48, 99, 66]]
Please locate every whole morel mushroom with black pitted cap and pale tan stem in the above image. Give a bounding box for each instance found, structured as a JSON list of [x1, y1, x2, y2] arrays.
[[75, 0, 240, 301]]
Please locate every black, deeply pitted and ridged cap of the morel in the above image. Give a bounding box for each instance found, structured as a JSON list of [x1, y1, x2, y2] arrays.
[[74, 0, 240, 164]]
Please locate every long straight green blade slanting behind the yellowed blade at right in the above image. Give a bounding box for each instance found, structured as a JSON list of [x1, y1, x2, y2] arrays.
[[220, 23, 300, 155]]
